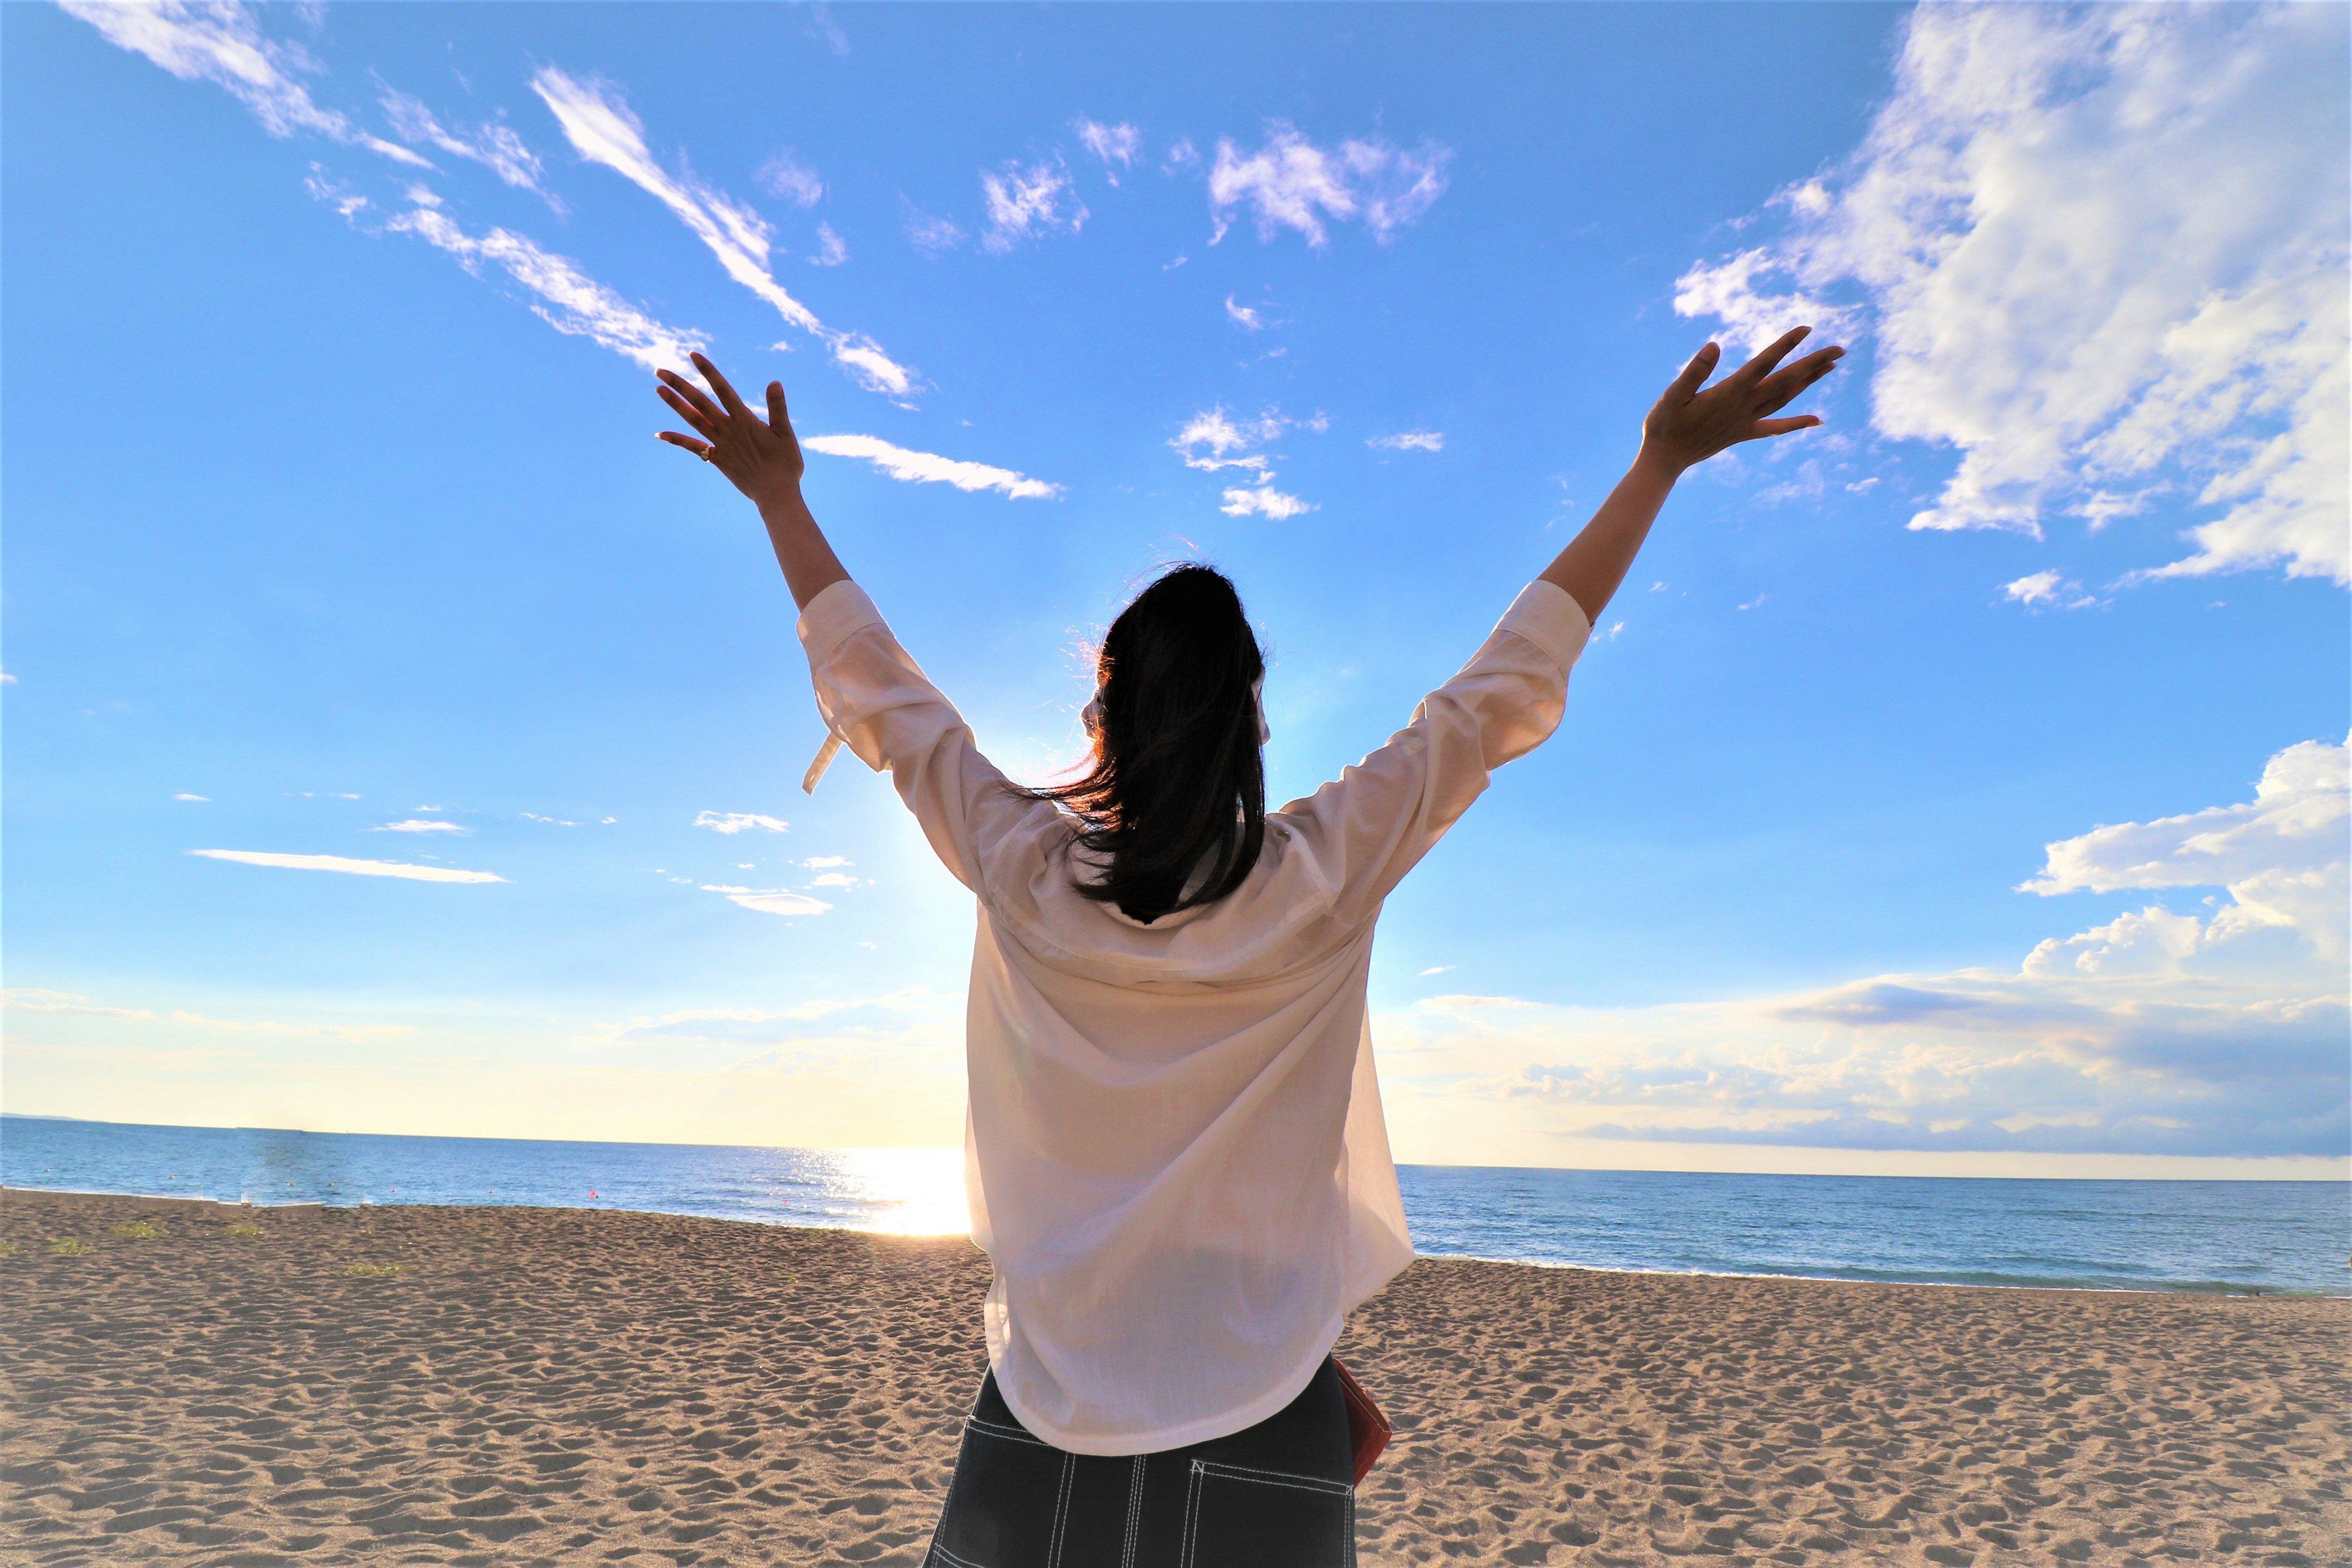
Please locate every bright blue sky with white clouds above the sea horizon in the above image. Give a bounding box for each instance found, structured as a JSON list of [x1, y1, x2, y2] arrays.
[[0, 5, 2352, 1175]]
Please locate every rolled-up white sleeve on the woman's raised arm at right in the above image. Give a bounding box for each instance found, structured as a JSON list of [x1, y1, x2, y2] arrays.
[[1282, 581, 1593, 912]]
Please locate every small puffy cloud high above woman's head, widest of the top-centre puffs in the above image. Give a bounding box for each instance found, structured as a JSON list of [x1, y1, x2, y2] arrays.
[[1209, 120, 1453, 247]]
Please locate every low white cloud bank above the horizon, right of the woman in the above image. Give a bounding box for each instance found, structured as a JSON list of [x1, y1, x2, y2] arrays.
[[1374, 741, 2347, 1159]]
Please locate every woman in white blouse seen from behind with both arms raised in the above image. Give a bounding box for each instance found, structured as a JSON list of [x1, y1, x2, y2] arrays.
[[661, 326, 1844, 1568]]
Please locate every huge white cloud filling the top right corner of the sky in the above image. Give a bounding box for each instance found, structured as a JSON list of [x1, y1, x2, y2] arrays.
[[1675, 5, 2352, 583]]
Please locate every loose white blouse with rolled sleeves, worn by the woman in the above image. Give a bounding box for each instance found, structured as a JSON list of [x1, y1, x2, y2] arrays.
[[800, 581, 1593, 1455]]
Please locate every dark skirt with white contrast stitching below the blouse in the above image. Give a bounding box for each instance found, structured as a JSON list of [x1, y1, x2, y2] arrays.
[[924, 1359, 1355, 1568]]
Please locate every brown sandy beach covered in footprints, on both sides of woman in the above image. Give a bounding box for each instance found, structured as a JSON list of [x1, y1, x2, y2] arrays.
[[0, 1192, 2352, 1568]]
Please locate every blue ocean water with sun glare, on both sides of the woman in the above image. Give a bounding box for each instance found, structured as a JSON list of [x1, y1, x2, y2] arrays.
[[0, 1117, 2352, 1295]]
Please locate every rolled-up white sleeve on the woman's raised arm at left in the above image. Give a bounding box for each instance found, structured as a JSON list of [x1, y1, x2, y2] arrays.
[[800, 581, 1054, 893]]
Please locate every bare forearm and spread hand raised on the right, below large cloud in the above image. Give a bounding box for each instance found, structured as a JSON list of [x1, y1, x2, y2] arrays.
[[1543, 326, 1846, 623]]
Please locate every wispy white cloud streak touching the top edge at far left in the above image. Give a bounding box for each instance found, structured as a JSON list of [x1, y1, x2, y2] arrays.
[[59, 0, 433, 169]]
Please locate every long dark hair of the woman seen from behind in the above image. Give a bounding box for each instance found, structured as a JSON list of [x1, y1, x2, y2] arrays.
[[1030, 562, 1265, 922]]
